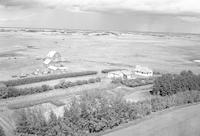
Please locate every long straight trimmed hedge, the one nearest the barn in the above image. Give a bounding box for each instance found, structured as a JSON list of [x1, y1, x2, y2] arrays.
[[2, 71, 97, 87]]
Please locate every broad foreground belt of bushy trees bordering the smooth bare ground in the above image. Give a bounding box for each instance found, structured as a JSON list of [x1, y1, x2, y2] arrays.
[[16, 90, 200, 136]]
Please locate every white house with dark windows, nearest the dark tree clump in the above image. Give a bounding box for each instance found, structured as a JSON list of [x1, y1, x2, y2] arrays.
[[135, 65, 153, 77]]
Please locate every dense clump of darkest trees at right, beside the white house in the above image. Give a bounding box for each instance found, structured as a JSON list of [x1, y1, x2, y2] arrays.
[[151, 71, 200, 96]]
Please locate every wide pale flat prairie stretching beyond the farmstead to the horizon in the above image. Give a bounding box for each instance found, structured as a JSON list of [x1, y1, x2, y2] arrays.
[[0, 30, 200, 80]]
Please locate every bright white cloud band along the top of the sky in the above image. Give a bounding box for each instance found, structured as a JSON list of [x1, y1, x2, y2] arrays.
[[0, 0, 200, 14]]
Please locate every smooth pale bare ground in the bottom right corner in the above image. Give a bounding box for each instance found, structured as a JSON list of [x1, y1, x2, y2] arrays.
[[104, 104, 200, 136]]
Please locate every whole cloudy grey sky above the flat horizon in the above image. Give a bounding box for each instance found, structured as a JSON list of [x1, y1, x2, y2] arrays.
[[0, 0, 200, 33]]
